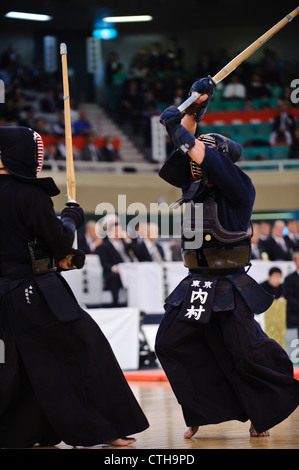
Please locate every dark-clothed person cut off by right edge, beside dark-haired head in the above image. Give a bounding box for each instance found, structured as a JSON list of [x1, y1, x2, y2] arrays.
[[283, 250, 299, 337]]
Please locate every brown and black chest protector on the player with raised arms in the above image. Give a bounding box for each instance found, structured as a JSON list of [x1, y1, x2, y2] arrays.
[[182, 199, 251, 271]]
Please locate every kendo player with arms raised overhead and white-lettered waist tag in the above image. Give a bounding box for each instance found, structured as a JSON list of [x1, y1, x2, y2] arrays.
[[155, 78, 299, 438]]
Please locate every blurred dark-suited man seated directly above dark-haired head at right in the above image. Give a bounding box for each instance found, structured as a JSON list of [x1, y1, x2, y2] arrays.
[[263, 220, 292, 261]]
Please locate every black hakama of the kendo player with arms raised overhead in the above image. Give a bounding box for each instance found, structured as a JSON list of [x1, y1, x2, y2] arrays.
[[156, 274, 299, 433]]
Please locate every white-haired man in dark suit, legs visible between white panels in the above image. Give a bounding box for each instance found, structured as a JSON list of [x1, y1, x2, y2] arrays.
[[97, 214, 139, 307]]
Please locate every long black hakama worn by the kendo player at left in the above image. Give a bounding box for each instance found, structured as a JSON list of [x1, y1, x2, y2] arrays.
[[0, 274, 148, 448]]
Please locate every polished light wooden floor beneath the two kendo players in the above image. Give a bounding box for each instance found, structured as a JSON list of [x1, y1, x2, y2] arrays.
[[49, 382, 299, 451]]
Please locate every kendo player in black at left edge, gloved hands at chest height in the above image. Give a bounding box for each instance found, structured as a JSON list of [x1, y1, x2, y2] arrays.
[[0, 127, 148, 448]]
